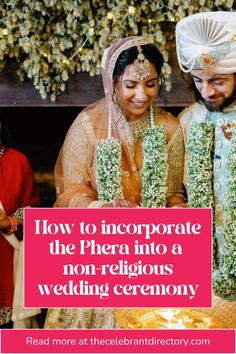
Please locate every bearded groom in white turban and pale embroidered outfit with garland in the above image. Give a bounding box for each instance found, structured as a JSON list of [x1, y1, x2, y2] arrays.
[[176, 11, 236, 304]]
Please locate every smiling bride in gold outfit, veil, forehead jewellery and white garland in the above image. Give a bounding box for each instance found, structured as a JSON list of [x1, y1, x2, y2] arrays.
[[45, 36, 184, 328]]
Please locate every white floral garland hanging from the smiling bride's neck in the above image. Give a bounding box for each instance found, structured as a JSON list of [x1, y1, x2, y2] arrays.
[[97, 126, 168, 208]]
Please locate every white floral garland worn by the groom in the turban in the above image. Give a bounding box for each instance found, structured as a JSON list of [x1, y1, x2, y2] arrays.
[[186, 121, 236, 296]]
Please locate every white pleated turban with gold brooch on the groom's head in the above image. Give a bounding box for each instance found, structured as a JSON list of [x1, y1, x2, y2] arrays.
[[176, 11, 236, 74]]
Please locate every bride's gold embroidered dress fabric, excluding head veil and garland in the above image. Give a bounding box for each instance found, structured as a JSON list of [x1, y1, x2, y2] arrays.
[[45, 100, 184, 328]]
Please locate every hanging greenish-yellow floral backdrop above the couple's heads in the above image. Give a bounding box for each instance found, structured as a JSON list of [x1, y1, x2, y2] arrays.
[[0, 0, 236, 101]]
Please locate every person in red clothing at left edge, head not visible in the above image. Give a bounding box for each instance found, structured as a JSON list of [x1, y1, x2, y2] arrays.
[[0, 122, 40, 328]]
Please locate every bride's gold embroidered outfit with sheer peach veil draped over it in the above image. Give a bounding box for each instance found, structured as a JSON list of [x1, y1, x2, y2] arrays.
[[45, 37, 184, 328]]
